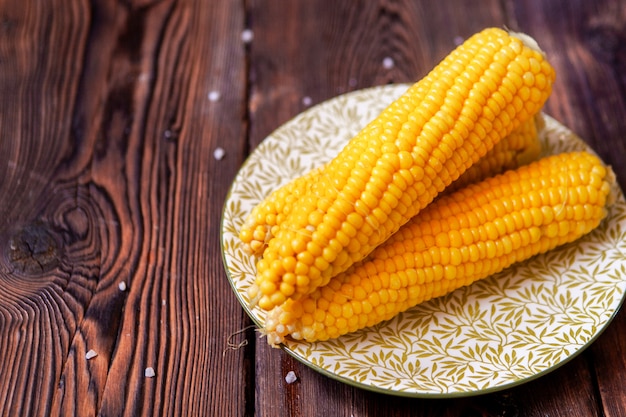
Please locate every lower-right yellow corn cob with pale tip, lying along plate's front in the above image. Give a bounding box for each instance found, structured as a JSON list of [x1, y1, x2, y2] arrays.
[[264, 152, 615, 345]]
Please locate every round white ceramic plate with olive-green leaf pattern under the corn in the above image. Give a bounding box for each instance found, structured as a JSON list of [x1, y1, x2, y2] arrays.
[[222, 85, 626, 397]]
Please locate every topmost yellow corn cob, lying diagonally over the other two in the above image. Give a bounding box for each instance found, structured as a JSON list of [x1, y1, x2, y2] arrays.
[[248, 29, 554, 310]]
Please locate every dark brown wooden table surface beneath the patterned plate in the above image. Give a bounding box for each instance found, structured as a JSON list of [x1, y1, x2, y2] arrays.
[[0, 0, 626, 417]]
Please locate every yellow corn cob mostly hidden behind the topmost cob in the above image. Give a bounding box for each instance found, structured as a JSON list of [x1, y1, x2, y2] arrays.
[[239, 114, 543, 255]]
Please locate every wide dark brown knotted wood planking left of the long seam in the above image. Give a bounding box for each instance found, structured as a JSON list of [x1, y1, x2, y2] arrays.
[[0, 1, 249, 416]]
